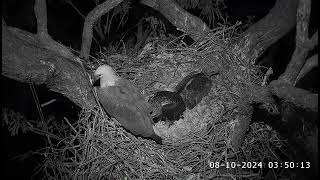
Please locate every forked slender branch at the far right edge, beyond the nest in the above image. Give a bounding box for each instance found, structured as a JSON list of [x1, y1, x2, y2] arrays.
[[251, 0, 318, 111]]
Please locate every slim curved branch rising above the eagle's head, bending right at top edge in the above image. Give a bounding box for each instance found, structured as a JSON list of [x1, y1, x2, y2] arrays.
[[81, 0, 123, 60]]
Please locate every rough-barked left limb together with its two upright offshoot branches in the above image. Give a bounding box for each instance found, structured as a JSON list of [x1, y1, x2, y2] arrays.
[[2, 0, 125, 108]]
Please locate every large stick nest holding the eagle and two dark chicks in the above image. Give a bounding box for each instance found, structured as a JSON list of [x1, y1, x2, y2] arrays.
[[38, 26, 290, 180]]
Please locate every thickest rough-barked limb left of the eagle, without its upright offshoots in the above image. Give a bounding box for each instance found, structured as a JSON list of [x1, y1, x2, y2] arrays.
[[2, 23, 96, 108]]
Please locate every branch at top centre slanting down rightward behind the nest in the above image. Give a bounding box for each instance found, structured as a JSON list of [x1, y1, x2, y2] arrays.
[[140, 0, 210, 40]]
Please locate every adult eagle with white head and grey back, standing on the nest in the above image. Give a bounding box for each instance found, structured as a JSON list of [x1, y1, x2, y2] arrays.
[[93, 65, 162, 144]]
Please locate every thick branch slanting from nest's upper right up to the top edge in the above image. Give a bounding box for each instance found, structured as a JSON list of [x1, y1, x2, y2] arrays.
[[233, 0, 298, 64]]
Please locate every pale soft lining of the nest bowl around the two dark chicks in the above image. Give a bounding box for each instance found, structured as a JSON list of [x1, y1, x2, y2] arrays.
[[142, 54, 222, 142]]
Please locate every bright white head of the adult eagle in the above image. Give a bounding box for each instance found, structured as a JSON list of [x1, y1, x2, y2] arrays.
[[94, 65, 119, 88]]
